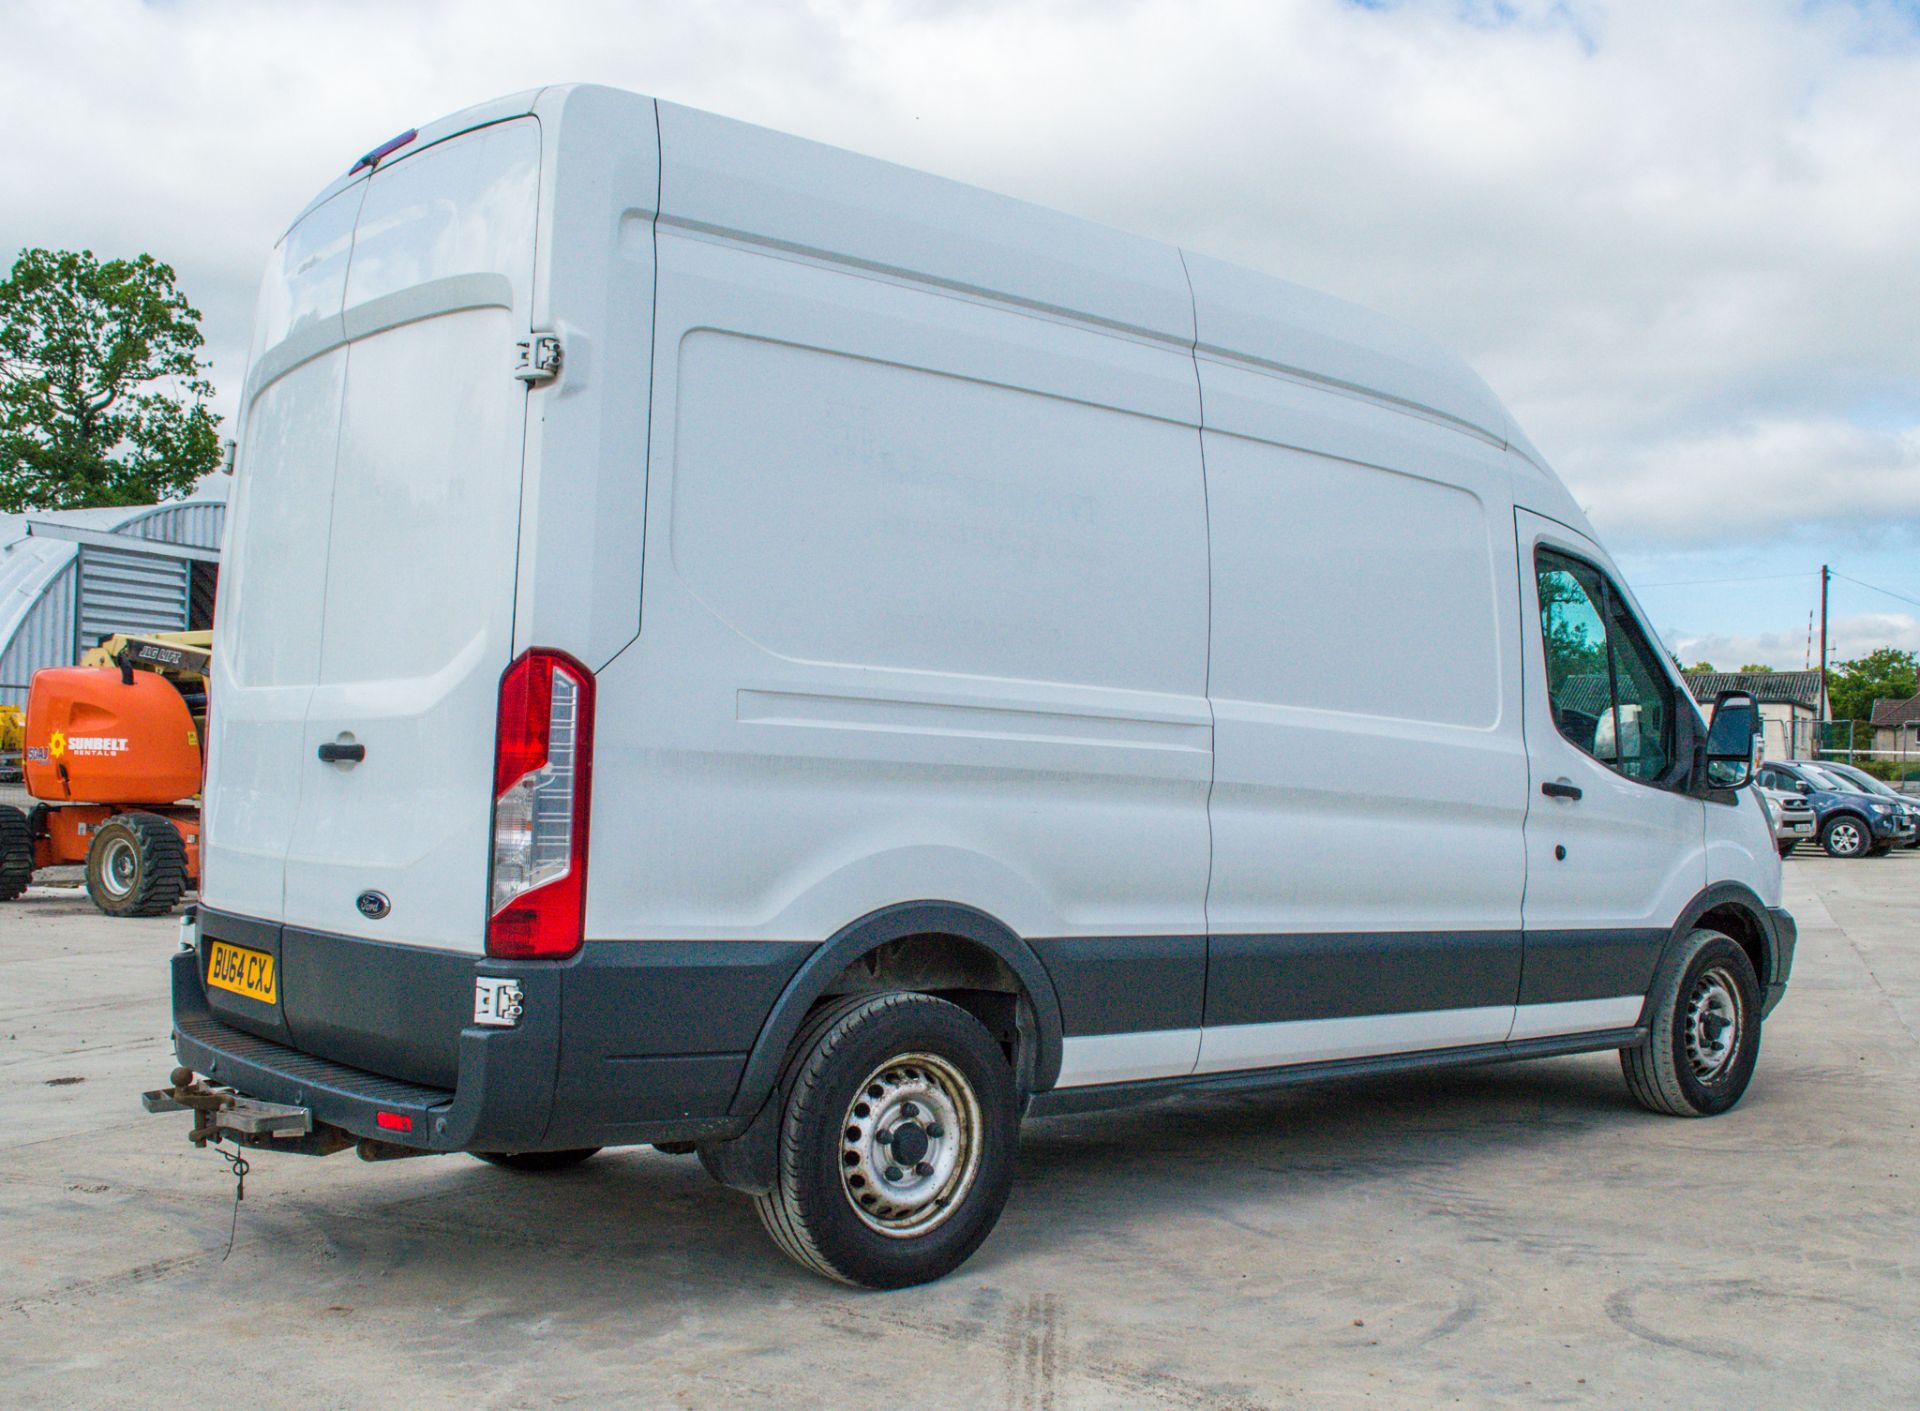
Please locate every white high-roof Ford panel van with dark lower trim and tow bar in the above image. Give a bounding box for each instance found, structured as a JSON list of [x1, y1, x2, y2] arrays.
[[150, 86, 1795, 1286]]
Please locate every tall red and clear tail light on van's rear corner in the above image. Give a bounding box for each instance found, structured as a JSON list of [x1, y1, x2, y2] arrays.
[[486, 649, 593, 960]]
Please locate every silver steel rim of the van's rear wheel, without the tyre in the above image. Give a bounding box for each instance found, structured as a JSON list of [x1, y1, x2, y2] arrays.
[[839, 1054, 985, 1240]]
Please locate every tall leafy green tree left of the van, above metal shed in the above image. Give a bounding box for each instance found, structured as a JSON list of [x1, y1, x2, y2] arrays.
[[0, 250, 221, 513]]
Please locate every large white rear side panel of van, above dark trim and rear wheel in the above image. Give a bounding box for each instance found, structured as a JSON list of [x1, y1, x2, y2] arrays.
[[588, 229, 1210, 982]]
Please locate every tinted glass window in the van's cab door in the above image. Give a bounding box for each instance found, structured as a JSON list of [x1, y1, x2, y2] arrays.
[[1534, 549, 1674, 783]]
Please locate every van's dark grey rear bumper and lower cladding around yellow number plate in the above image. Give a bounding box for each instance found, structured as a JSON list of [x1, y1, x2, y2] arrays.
[[173, 908, 812, 1152]]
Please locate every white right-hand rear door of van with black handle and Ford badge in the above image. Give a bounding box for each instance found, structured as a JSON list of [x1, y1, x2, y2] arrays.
[[284, 117, 541, 956]]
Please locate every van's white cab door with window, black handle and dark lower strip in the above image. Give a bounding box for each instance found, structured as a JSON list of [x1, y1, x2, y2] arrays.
[[1513, 509, 1707, 1039]]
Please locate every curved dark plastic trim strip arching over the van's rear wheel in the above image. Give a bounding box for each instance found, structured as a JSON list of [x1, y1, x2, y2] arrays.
[[730, 900, 1062, 1115]]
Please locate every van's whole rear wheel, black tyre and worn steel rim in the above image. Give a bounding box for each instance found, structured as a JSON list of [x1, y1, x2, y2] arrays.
[[755, 994, 1020, 1288]]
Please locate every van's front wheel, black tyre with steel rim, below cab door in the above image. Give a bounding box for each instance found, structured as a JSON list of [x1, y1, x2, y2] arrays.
[[1620, 929, 1761, 1117]]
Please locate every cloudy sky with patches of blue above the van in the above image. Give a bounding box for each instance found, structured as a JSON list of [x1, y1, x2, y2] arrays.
[[0, 0, 1920, 668]]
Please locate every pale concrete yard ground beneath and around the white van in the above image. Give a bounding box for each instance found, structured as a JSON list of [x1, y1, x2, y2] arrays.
[[0, 852, 1920, 1411]]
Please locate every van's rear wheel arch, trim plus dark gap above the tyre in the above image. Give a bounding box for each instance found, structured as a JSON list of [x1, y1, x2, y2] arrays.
[[732, 900, 1062, 1115]]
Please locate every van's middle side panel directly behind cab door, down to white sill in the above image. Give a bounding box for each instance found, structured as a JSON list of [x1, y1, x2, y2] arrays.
[[1200, 351, 1526, 1071]]
